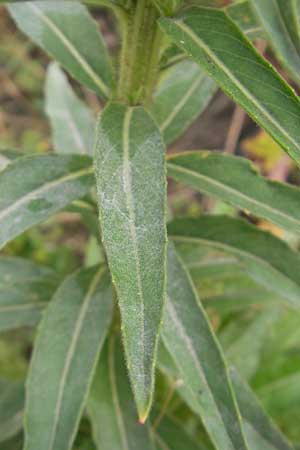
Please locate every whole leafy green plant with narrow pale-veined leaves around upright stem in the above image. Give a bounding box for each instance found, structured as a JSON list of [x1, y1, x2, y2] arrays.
[[0, 0, 300, 450]]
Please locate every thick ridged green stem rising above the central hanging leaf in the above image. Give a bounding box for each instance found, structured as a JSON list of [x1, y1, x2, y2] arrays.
[[117, 0, 162, 105]]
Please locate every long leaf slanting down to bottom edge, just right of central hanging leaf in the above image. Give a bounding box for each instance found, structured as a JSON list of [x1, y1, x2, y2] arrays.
[[162, 246, 248, 450]]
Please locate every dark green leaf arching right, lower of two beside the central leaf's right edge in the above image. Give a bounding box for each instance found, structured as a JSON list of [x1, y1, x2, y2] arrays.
[[169, 216, 300, 307]]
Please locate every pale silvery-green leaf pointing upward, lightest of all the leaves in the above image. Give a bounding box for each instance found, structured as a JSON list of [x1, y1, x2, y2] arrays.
[[46, 63, 95, 155]]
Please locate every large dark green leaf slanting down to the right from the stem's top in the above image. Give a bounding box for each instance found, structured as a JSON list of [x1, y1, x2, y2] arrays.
[[160, 7, 300, 168]]
